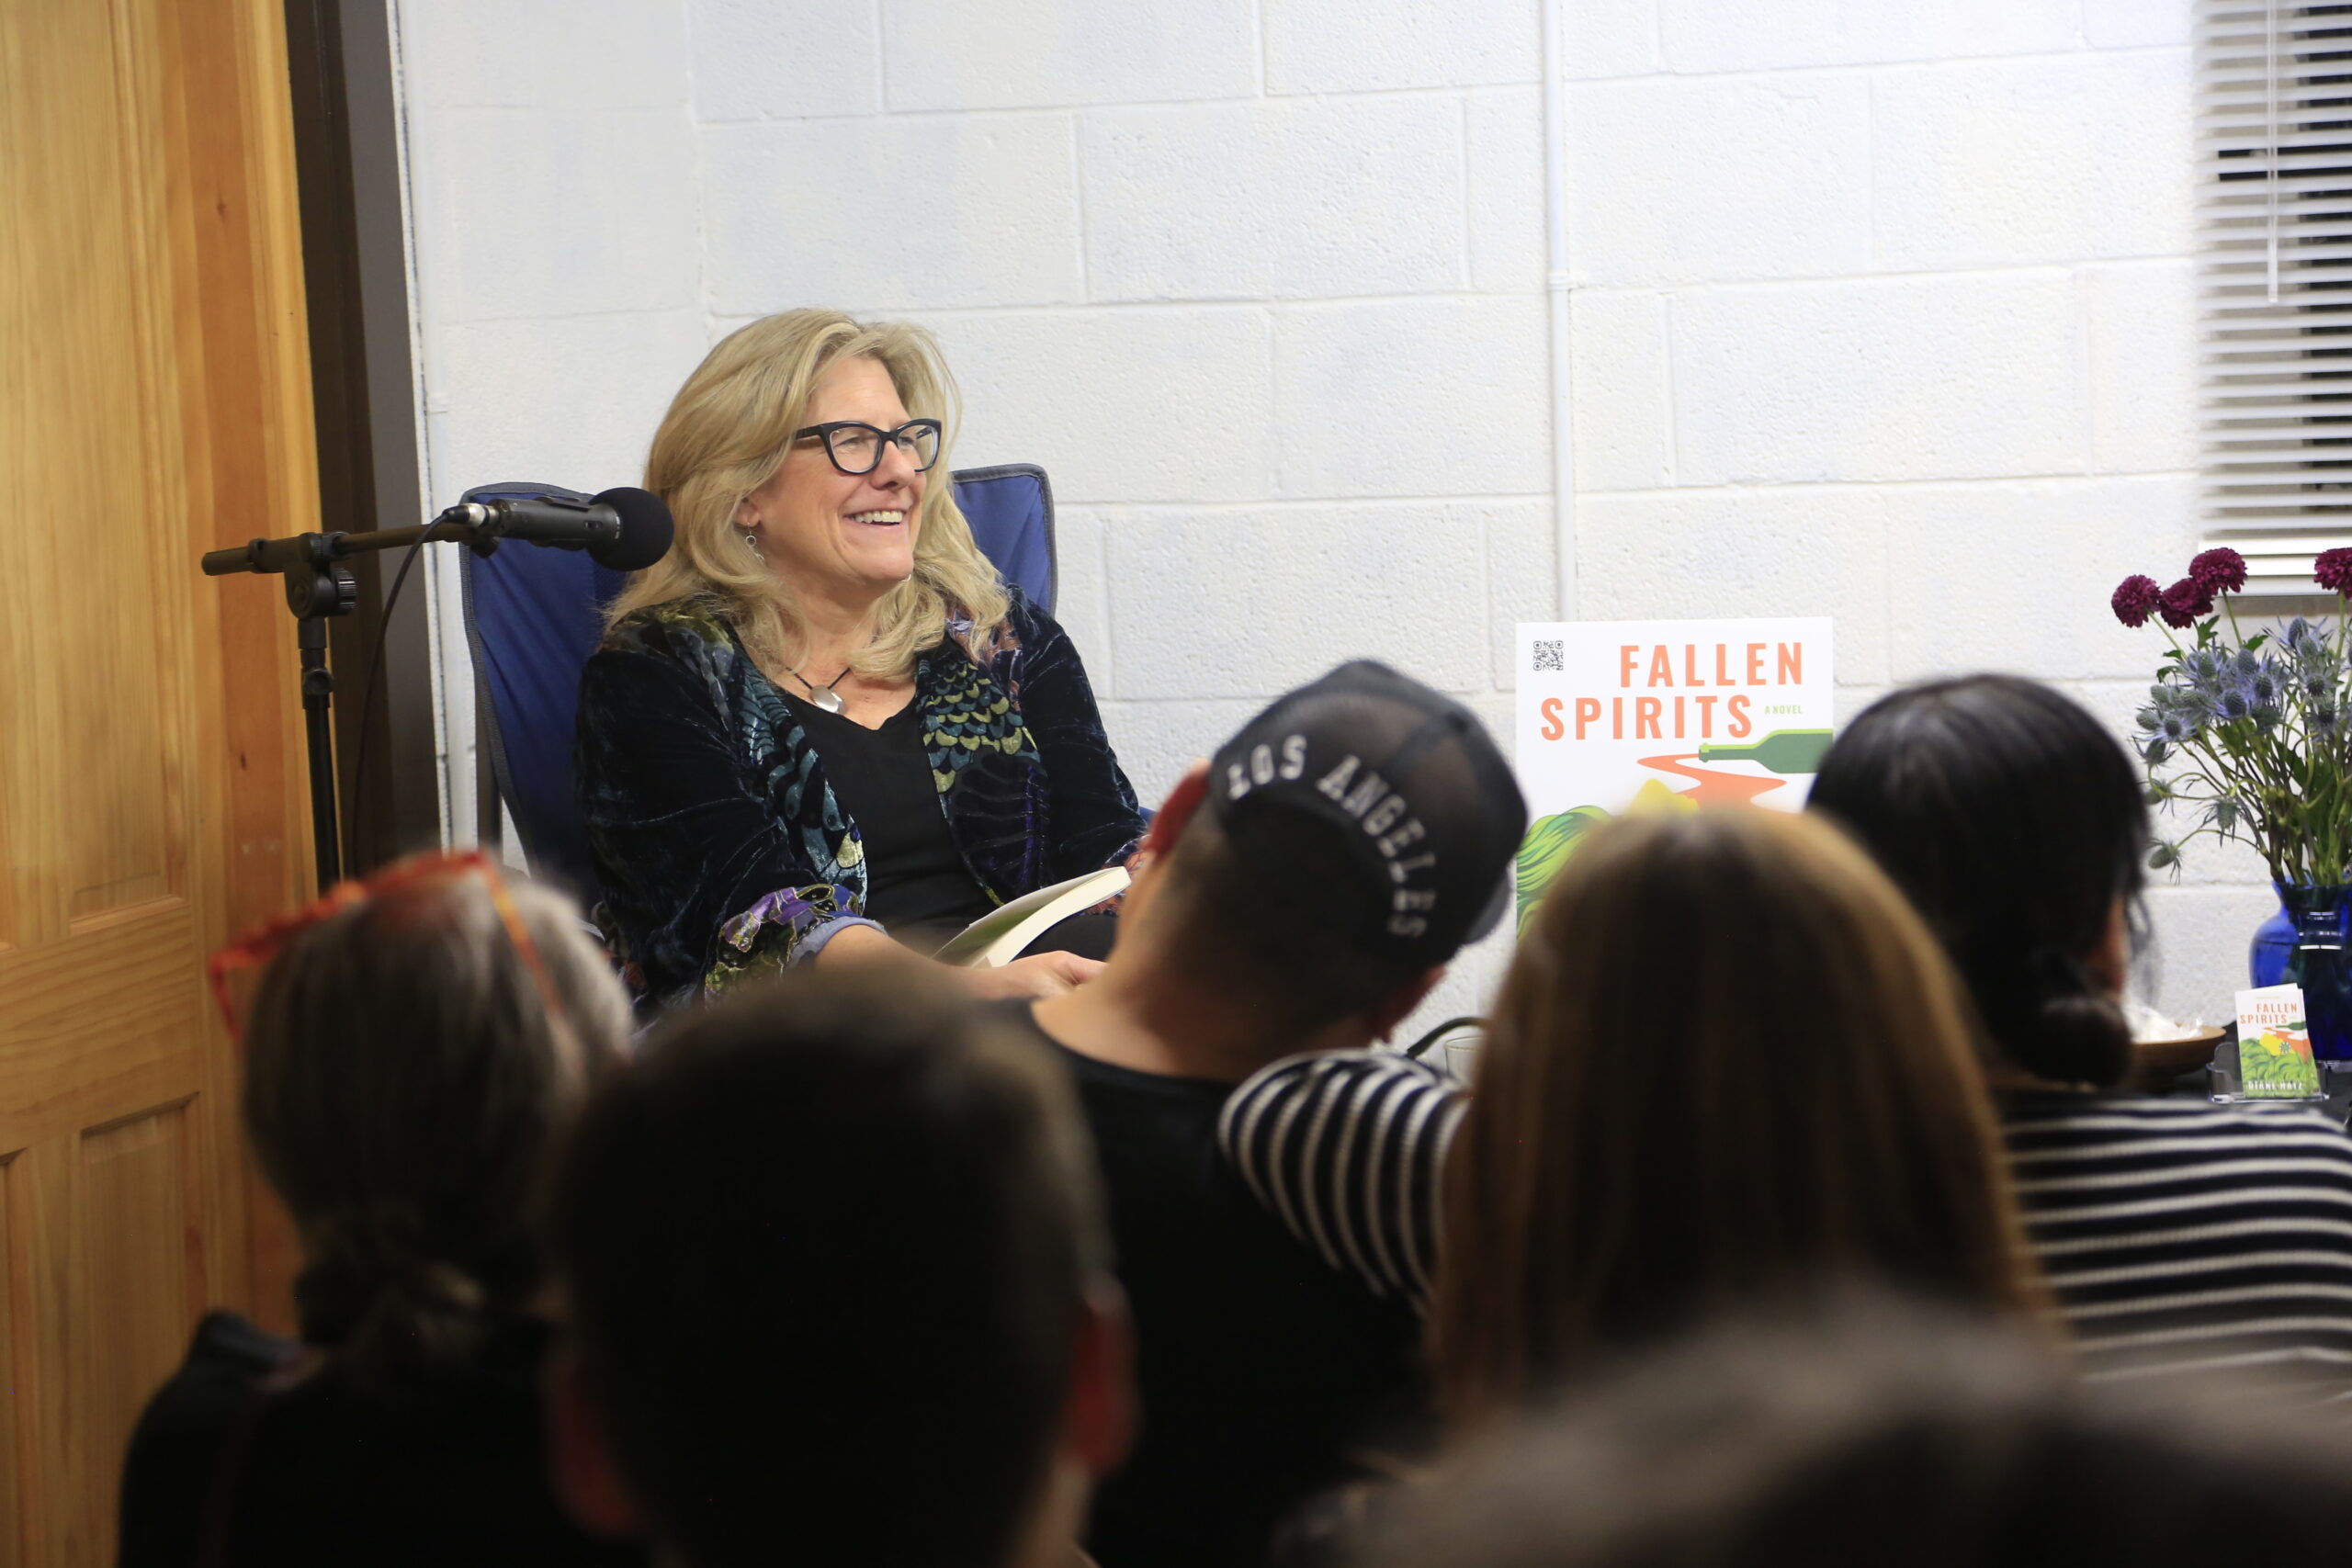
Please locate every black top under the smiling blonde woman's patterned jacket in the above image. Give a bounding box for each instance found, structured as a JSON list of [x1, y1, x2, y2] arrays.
[[786, 694, 995, 952]]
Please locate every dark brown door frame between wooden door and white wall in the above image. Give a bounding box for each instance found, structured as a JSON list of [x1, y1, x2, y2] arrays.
[[285, 0, 442, 874]]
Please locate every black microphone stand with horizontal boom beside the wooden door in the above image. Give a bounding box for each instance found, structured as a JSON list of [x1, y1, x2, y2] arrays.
[[202, 505, 499, 894]]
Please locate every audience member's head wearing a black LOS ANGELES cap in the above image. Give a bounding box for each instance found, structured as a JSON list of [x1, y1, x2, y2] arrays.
[[1122, 660, 1526, 1048]]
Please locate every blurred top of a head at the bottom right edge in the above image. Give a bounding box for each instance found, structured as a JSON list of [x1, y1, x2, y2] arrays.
[[1357, 1312, 2352, 1568]]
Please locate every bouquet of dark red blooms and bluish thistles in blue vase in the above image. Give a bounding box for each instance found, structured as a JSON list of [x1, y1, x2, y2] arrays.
[[2109, 550, 2352, 1060]]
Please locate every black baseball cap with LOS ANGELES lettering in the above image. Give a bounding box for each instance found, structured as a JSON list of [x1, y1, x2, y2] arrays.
[[1209, 659, 1526, 968]]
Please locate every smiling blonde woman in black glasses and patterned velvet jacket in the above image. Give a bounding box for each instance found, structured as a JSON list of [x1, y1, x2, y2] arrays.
[[576, 310, 1143, 1004]]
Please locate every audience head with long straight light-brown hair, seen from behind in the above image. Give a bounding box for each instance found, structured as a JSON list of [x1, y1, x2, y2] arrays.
[[1430, 808, 2037, 1427]]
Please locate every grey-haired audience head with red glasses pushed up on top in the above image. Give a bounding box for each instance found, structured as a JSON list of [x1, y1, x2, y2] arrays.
[[244, 863, 630, 1382]]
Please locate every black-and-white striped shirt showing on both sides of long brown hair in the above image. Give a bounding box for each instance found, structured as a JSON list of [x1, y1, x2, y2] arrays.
[[1218, 1051, 2352, 1394]]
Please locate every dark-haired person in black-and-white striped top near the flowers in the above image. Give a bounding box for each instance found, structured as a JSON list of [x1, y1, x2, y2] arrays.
[[1811, 674, 2352, 1389]]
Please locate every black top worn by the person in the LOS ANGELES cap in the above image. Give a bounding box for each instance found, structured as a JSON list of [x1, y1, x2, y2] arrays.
[[1009, 1004, 1425, 1568]]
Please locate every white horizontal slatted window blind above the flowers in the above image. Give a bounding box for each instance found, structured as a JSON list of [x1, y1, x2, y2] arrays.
[[2197, 0, 2352, 592]]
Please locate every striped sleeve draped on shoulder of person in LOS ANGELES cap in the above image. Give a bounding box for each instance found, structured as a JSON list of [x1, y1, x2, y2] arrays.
[[1216, 1051, 1467, 1309]]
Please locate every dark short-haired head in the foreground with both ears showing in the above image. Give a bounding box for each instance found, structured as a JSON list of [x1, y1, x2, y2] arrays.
[[550, 968, 1131, 1568]]
